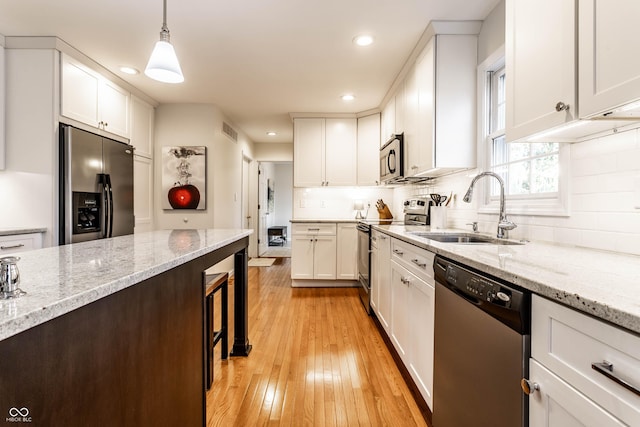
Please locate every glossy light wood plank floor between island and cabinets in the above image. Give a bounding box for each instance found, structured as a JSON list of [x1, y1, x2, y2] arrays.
[[207, 258, 426, 427]]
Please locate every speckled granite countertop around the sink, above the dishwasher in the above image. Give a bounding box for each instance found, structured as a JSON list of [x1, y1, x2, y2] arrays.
[[374, 225, 640, 334]]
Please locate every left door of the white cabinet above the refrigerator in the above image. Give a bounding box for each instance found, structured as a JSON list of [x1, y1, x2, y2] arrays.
[[60, 55, 100, 128]]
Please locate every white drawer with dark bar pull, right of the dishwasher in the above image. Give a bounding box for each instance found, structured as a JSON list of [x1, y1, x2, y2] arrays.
[[531, 296, 640, 425]]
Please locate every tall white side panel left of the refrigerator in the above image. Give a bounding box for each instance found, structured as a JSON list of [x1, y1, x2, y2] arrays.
[[0, 49, 58, 246]]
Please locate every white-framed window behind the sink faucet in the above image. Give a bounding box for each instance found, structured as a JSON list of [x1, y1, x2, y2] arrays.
[[479, 59, 568, 215]]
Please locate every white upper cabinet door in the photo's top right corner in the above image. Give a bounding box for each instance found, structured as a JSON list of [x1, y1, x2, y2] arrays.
[[578, 0, 640, 117]]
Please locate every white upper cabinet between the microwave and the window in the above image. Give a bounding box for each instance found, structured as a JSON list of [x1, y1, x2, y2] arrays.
[[404, 34, 478, 176]]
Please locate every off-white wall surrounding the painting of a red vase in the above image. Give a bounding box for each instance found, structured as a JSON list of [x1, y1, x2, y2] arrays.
[[154, 104, 253, 271]]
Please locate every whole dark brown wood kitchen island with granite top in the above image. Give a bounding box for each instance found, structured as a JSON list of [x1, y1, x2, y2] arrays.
[[0, 229, 252, 426]]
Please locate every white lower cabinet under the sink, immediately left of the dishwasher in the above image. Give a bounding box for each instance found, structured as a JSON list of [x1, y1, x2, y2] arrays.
[[379, 239, 435, 408]]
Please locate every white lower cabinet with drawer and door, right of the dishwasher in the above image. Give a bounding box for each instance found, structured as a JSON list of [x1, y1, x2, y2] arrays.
[[529, 296, 640, 427]]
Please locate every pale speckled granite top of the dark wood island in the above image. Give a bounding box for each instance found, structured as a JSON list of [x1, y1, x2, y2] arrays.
[[0, 229, 253, 340]]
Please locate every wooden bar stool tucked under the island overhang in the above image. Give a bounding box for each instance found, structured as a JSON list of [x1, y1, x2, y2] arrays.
[[204, 273, 229, 390]]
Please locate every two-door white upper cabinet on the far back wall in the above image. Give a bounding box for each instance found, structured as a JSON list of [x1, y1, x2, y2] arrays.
[[293, 118, 358, 187]]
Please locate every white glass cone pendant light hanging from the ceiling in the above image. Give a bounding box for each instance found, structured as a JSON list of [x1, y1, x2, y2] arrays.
[[144, 0, 184, 83]]
